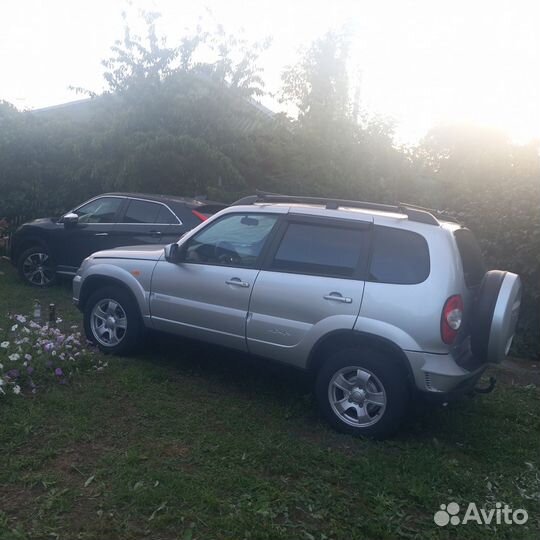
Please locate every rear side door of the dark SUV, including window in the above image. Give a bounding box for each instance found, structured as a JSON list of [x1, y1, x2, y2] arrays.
[[115, 198, 187, 246]]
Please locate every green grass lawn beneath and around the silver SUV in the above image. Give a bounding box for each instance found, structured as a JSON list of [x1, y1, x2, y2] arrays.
[[0, 263, 540, 540]]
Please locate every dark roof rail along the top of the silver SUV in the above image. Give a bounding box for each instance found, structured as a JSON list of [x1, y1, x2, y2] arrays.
[[231, 191, 439, 225]]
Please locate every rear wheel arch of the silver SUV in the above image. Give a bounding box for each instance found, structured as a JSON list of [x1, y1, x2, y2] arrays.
[[306, 330, 414, 385]]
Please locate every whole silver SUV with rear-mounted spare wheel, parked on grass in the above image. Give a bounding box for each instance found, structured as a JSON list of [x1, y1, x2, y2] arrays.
[[73, 195, 521, 437]]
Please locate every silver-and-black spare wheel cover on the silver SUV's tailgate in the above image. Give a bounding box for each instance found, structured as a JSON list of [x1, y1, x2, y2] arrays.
[[471, 270, 521, 363]]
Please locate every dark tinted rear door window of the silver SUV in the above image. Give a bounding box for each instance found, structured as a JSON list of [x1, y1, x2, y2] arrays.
[[271, 223, 368, 277]]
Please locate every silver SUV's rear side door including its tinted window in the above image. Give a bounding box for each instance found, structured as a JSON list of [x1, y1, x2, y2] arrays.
[[246, 215, 372, 366]]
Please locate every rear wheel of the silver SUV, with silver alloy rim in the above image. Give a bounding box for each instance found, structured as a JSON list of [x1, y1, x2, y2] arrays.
[[315, 347, 410, 439]]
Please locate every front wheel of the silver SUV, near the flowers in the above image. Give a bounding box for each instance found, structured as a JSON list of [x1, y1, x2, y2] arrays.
[[84, 286, 145, 355]]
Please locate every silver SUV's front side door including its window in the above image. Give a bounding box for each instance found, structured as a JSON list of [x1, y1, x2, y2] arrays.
[[150, 212, 278, 350]]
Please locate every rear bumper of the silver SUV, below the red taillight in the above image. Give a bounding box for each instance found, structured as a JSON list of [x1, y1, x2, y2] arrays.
[[405, 351, 487, 394]]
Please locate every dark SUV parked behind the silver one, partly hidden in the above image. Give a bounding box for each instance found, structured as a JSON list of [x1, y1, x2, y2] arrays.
[[10, 193, 225, 287]]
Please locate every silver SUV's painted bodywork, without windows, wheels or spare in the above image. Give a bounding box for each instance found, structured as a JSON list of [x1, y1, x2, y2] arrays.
[[73, 204, 492, 393]]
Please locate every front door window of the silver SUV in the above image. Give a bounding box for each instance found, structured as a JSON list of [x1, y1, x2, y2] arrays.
[[185, 214, 277, 268]]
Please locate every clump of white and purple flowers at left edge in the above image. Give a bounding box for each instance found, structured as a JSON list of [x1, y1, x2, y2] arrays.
[[0, 315, 107, 396]]
